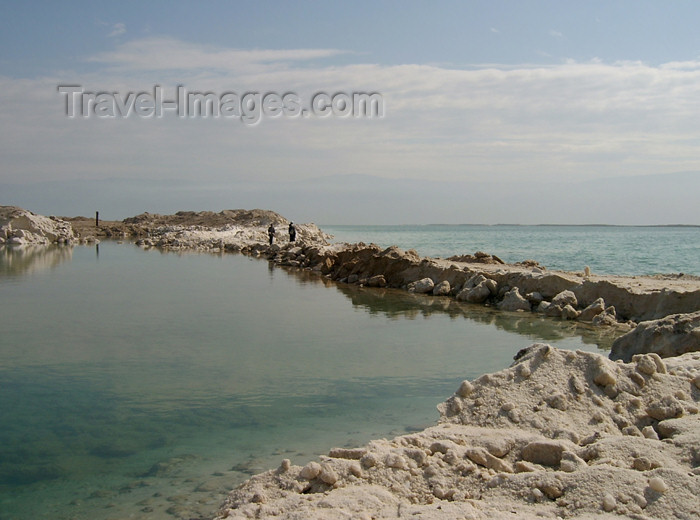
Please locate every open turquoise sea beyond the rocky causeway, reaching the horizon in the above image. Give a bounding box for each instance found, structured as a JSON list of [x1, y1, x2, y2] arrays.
[[322, 225, 700, 275]]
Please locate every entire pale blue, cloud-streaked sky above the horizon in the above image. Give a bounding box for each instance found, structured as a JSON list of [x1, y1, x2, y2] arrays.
[[0, 0, 700, 225]]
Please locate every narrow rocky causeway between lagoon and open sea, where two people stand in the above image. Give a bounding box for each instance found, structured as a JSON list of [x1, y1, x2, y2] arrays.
[[60, 210, 700, 328]]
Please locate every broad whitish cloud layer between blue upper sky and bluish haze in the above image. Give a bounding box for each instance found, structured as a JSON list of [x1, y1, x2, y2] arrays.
[[0, 38, 700, 195]]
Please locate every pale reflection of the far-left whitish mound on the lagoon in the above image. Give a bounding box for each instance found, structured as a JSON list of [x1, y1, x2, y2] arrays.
[[0, 245, 73, 277]]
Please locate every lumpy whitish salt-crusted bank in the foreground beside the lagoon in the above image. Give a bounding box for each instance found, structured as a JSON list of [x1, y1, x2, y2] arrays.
[[217, 344, 700, 520]]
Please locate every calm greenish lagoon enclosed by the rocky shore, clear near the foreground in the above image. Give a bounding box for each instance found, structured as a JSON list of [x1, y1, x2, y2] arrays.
[[0, 242, 612, 520]]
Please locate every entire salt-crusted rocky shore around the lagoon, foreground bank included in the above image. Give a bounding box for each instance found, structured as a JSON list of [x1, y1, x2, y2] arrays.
[[0, 206, 700, 520]]
